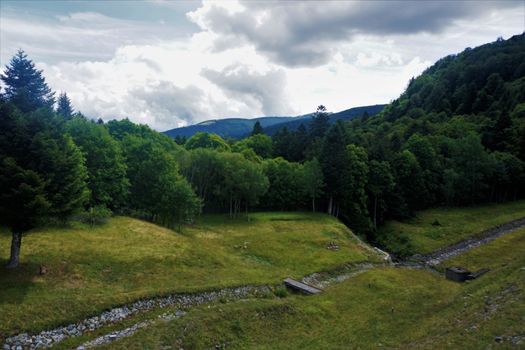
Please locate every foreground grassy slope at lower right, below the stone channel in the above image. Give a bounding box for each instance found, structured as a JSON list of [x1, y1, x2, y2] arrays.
[[105, 229, 525, 349]]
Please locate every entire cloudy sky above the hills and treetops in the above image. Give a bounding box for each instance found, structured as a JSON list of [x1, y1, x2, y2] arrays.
[[0, 0, 525, 130]]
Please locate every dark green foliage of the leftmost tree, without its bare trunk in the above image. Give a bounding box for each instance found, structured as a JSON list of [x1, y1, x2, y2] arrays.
[[0, 102, 89, 222]]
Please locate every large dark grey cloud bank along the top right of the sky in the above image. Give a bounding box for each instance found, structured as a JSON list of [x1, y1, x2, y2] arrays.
[[189, 1, 523, 66]]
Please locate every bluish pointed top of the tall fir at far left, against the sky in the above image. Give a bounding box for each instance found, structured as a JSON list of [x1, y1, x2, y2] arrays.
[[0, 50, 55, 112]]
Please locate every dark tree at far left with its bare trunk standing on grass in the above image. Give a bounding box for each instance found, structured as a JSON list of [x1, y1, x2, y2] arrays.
[[0, 101, 88, 268]]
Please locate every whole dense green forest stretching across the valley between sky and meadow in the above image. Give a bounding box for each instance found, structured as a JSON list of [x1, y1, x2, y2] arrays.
[[0, 34, 525, 267]]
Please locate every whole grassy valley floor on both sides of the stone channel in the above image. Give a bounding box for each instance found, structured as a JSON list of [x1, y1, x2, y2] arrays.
[[0, 202, 525, 349]]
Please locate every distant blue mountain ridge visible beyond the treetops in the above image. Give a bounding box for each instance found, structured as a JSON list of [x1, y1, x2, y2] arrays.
[[164, 104, 386, 139]]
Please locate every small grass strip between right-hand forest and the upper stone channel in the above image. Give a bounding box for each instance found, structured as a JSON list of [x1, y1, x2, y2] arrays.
[[378, 201, 525, 256]]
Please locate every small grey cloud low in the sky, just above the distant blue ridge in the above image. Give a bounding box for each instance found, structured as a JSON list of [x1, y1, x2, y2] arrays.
[[202, 65, 292, 115]]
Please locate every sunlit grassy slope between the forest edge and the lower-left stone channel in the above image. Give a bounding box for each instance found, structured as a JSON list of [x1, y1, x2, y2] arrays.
[[0, 213, 372, 336]]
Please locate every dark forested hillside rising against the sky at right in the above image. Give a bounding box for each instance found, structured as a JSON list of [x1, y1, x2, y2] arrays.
[[384, 33, 525, 126]]
